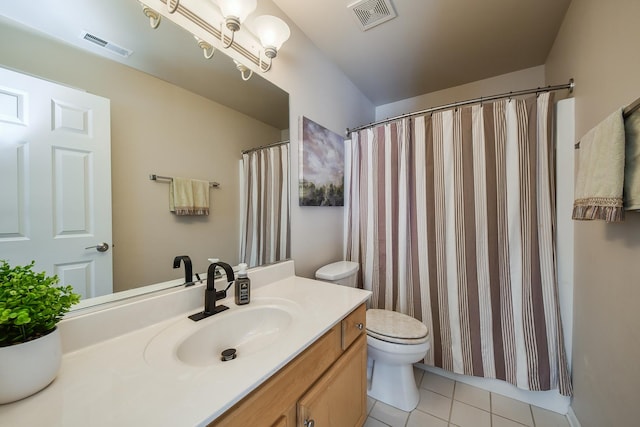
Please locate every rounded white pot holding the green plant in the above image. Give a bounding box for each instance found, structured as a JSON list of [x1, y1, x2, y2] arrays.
[[0, 328, 62, 404]]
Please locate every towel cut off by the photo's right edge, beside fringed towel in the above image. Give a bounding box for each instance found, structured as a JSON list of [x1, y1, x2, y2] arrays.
[[624, 109, 640, 211]]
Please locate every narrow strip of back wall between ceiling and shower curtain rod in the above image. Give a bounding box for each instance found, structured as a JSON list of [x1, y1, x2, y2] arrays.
[[376, 65, 544, 120]]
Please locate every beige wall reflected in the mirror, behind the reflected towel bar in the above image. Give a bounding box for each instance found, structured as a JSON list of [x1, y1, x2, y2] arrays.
[[0, 23, 281, 291]]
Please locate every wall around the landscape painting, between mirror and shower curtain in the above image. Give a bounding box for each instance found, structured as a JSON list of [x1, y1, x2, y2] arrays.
[[244, 0, 374, 277]]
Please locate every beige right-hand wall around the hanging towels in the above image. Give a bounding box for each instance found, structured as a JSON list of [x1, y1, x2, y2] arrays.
[[546, 0, 640, 427]]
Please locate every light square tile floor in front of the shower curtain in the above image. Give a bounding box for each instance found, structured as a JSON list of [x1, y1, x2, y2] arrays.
[[364, 368, 570, 427]]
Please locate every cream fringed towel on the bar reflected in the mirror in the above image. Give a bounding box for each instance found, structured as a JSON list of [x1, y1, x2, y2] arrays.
[[169, 177, 209, 215]]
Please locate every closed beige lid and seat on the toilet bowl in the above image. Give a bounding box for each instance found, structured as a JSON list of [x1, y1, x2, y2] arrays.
[[367, 309, 429, 344]]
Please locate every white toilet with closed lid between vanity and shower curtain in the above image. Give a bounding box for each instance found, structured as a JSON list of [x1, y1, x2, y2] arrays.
[[316, 261, 429, 412]]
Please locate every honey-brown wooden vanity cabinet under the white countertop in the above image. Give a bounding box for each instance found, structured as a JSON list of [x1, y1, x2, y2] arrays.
[[209, 304, 367, 427]]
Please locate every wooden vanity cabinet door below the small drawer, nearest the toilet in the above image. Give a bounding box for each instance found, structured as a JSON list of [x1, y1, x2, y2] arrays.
[[297, 335, 367, 427]]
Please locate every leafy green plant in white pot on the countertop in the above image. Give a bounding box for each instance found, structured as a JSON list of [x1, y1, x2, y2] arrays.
[[0, 260, 80, 404]]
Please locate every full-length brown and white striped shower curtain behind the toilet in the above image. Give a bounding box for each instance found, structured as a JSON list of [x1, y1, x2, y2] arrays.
[[345, 93, 571, 395]]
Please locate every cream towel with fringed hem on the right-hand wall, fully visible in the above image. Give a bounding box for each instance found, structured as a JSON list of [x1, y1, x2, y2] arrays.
[[572, 108, 625, 222]]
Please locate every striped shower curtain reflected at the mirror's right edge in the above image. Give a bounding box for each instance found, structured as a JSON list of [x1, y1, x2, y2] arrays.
[[240, 144, 290, 267]]
